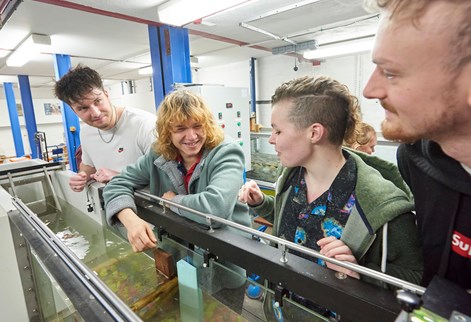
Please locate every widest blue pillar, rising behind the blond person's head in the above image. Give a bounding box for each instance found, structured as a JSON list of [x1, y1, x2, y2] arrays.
[[148, 26, 191, 106]]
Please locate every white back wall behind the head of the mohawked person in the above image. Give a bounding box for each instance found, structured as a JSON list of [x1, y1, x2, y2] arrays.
[[194, 53, 397, 163]]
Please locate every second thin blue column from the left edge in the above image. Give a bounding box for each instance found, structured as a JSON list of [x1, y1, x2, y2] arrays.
[[18, 75, 38, 159]]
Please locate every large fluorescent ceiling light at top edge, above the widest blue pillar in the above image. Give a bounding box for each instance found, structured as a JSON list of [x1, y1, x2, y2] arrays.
[[157, 0, 250, 26]]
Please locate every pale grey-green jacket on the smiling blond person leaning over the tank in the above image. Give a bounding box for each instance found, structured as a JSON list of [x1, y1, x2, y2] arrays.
[[103, 140, 251, 227]]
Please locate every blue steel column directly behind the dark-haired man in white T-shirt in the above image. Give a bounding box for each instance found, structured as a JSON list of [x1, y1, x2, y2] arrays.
[[54, 54, 80, 172]]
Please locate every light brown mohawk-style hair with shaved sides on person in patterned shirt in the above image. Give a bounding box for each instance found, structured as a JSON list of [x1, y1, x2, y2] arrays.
[[272, 76, 361, 145]]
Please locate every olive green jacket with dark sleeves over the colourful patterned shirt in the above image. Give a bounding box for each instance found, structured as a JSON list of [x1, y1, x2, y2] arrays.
[[253, 150, 422, 286]]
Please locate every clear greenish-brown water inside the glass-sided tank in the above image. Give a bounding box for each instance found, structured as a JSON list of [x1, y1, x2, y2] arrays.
[[37, 201, 251, 321]]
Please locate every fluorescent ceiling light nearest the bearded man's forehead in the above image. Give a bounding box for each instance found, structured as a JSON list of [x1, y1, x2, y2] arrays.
[[303, 38, 374, 59]]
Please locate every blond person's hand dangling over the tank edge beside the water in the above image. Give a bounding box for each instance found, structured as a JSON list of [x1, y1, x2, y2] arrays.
[[117, 208, 157, 252]]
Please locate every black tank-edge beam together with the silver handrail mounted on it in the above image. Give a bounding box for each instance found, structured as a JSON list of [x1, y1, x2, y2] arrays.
[[135, 191, 424, 322]]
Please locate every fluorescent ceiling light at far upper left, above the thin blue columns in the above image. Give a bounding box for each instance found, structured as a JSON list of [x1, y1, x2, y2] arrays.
[[6, 34, 51, 67]]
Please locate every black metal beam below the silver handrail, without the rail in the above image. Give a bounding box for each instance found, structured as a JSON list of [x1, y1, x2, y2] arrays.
[[136, 196, 400, 322]]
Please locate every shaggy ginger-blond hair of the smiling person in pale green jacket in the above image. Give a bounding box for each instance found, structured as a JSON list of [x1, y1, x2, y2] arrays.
[[153, 90, 224, 160]]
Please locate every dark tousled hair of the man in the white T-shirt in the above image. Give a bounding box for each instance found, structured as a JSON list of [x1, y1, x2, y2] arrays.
[[54, 64, 105, 105]]
